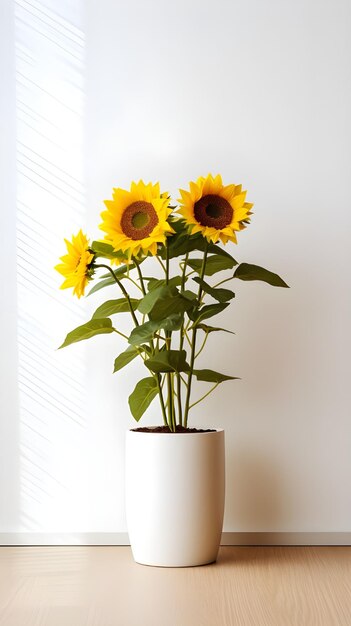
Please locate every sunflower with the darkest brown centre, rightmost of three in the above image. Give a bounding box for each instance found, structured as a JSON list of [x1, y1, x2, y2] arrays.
[[179, 174, 253, 243]]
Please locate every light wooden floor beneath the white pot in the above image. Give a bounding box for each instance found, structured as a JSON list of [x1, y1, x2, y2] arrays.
[[0, 546, 351, 626]]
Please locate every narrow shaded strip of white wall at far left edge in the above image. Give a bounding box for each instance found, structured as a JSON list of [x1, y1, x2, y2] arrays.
[[0, 0, 19, 531]]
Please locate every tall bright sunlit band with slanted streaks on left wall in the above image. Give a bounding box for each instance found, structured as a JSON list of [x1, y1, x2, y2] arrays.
[[15, 0, 89, 531]]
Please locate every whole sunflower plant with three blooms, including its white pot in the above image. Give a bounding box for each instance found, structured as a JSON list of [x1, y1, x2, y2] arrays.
[[56, 174, 287, 566]]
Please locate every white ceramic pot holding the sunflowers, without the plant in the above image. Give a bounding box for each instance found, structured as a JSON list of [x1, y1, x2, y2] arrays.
[[126, 430, 225, 567]]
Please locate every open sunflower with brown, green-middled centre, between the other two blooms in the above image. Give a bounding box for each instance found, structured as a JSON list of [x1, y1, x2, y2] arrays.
[[100, 180, 174, 259]]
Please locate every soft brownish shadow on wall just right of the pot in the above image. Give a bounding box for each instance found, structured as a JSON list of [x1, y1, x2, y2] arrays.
[[226, 446, 286, 532]]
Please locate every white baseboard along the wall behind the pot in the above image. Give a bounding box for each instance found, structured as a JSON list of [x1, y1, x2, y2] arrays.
[[0, 532, 351, 546]]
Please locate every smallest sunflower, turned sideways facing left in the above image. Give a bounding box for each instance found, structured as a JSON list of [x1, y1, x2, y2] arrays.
[[55, 230, 94, 298]]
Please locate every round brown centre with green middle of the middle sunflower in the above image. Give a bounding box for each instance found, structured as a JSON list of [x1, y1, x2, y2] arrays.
[[121, 200, 158, 241]]
